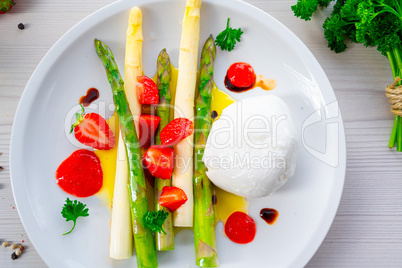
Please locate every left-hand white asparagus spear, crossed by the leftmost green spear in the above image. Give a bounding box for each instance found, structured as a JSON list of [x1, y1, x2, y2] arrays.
[[109, 7, 142, 259]]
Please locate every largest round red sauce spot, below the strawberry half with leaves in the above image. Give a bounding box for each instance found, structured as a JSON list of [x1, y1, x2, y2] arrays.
[[56, 149, 103, 197]]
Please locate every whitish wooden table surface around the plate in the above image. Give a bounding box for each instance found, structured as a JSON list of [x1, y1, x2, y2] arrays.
[[0, 0, 402, 267]]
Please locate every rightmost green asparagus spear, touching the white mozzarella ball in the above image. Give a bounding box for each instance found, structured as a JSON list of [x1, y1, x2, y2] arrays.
[[194, 35, 219, 267]]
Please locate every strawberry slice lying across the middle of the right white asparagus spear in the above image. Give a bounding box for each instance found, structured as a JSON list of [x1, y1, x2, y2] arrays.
[[160, 117, 194, 146]]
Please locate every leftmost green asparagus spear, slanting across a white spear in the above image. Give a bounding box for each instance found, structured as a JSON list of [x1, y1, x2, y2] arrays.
[[95, 39, 158, 268]]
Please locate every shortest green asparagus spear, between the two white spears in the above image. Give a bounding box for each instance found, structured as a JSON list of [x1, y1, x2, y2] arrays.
[[155, 49, 174, 251]]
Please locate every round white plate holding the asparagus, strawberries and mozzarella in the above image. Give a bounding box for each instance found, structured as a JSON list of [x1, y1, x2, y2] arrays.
[[10, 0, 346, 268]]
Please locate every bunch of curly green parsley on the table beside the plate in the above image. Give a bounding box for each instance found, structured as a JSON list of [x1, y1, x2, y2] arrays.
[[291, 0, 402, 151]]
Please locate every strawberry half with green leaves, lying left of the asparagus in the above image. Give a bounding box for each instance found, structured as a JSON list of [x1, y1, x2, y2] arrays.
[[70, 105, 115, 150]]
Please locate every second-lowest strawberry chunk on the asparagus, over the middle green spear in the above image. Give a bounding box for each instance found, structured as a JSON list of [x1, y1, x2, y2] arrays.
[[144, 145, 174, 180]]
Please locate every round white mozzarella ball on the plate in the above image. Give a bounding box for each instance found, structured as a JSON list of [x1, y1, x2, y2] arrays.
[[203, 95, 298, 198]]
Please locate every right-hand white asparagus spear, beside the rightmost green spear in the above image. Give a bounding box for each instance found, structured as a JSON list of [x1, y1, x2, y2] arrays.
[[172, 0, 202, 227]]
